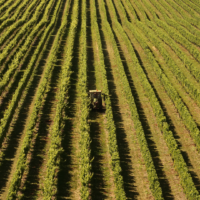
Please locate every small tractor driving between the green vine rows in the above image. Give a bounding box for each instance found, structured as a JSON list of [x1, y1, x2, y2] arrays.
[[89, 90, 105, 110]]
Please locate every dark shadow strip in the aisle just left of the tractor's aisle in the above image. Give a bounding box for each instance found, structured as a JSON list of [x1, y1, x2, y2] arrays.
[[56, 0, 82, 199]]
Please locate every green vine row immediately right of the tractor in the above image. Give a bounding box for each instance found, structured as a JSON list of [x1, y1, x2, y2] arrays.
[[90, 0, 125, 199]]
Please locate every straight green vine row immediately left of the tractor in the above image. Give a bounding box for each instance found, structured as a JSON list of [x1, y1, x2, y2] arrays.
[[78, 0, 92, 200]]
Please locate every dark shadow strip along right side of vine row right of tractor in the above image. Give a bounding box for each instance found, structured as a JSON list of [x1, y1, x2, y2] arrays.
[[96, 1, 138, 199]]
